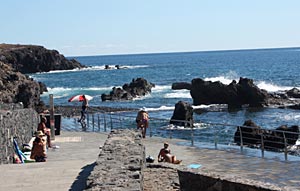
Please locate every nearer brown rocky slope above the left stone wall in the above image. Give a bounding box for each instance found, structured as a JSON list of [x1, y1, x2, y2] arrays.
[[0, 61, 45, 108]]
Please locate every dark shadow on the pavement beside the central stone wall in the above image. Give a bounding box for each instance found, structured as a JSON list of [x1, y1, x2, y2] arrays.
[[69, 162, 96, 191]]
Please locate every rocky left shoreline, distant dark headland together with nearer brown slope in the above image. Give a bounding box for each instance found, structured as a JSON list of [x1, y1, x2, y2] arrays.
[[0, 44, 85, 111]]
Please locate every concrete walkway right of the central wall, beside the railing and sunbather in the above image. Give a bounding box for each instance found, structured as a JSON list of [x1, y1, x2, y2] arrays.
[[144, 137, 300, 191]]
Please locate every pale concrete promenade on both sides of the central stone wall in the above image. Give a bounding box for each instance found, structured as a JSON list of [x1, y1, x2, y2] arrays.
[[0, 131, 300, 191]]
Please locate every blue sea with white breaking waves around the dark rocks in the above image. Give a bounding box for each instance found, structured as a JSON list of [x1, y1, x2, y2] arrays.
[[30, 48, 300, 137]]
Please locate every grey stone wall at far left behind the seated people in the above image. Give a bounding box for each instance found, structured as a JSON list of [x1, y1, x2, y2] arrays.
[[0, 107, 38, 164]]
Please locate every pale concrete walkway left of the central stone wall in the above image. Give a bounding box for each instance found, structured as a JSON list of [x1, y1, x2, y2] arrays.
[[0, 132, 107, 191]]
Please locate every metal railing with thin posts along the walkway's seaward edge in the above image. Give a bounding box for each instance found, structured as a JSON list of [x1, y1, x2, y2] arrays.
[[68, 110, 299, 160]]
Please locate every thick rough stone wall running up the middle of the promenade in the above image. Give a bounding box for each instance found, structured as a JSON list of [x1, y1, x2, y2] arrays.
[[86, 130, 145, 191]]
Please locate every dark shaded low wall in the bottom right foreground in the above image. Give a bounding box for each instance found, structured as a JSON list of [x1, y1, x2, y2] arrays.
[[178, 169, 281, 191]]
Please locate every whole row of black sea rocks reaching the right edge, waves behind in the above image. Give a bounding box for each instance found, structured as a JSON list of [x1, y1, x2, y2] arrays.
[[172, 77, 300, 109]]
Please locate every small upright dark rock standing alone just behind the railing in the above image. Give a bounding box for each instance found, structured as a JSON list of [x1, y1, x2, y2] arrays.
[[170, 101, 193, 127]]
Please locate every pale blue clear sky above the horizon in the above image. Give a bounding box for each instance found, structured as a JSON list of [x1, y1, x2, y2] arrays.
[[0, 0, 300, 56]]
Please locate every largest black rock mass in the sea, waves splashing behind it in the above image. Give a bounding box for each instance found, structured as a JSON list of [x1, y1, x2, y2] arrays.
[[191, 78, 268, 108]]
